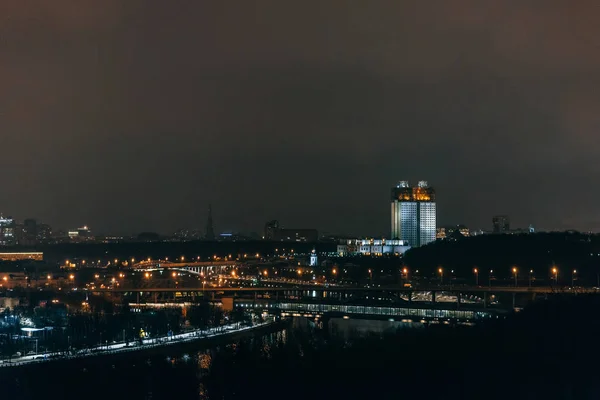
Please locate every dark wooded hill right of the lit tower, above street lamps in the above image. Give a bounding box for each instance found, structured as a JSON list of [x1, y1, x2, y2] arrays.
[[404, 232, 600, 285]]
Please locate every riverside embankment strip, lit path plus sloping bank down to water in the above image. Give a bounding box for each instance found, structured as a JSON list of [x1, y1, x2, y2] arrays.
[[0, 320, 288, 368]]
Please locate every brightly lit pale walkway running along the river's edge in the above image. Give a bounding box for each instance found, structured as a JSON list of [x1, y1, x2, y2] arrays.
[[0, 321, 274, 367]]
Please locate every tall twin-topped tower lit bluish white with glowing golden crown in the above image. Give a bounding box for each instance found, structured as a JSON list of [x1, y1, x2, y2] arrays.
[[391, 181, 436, 247]]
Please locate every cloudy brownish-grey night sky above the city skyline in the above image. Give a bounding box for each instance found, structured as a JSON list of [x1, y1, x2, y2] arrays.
[[0, 0, 600, 235]]
